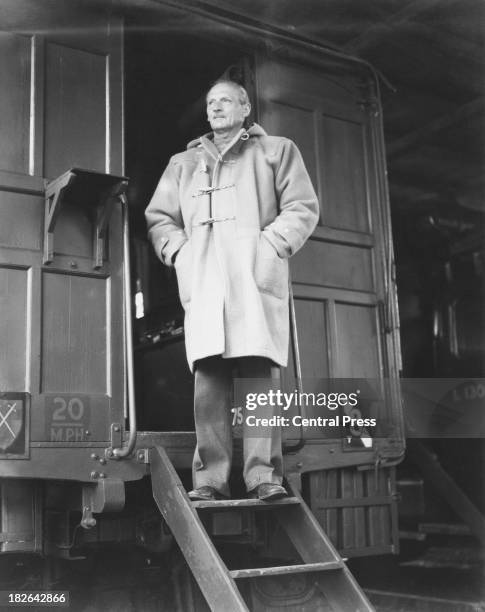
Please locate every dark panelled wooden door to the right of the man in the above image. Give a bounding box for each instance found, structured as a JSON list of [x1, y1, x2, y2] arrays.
[[256, 59, 401, 460]]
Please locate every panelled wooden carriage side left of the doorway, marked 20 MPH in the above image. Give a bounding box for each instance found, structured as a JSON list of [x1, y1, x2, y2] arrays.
[[0, 0, 125, 443]]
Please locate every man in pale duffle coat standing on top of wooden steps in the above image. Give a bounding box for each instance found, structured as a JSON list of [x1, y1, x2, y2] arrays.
[[146, 80, 319, 500]]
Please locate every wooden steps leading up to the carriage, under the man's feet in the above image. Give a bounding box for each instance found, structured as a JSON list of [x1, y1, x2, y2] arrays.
[[150, 446, 374, 612]]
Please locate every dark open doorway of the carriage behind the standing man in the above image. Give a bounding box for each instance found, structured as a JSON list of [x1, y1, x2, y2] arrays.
[[125, 24, 249, 431]]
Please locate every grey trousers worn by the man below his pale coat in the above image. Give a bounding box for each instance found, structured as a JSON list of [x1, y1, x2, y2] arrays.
[[192, 355, 283, 495]]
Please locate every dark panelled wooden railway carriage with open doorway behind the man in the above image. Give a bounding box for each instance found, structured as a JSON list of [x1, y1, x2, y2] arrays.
[[0, 0, 404, 610]]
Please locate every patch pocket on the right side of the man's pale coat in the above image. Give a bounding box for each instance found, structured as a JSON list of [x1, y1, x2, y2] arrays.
[[254, 233, 288, 299]]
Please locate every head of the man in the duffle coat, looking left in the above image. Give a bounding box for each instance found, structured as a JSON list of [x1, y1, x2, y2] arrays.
[[207, 83, 251, 132]]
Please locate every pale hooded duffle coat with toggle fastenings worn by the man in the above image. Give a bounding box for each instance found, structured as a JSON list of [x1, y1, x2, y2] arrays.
[[145, 124, 319, 370]]
